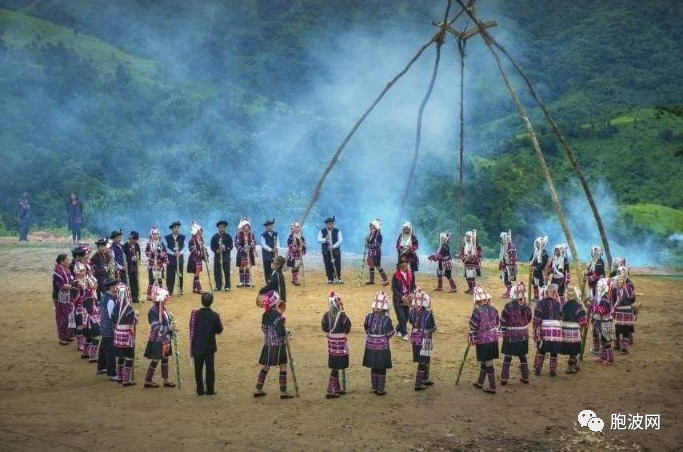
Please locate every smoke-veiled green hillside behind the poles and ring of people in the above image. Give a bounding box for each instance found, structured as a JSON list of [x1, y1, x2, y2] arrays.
[[0, 0, 683, 266]]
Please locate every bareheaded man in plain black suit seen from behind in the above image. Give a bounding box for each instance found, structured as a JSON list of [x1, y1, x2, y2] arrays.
[[190, 293, 223, 395]]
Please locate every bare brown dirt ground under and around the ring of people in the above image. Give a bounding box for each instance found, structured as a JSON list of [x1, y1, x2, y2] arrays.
[[0, 239, 683, 451]]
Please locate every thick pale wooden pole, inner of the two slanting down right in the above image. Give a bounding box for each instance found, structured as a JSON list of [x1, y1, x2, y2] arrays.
[[456, 0, 581, 277]]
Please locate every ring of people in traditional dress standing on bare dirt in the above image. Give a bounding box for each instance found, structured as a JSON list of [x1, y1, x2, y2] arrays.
[[53, 217, 640, 399]]
